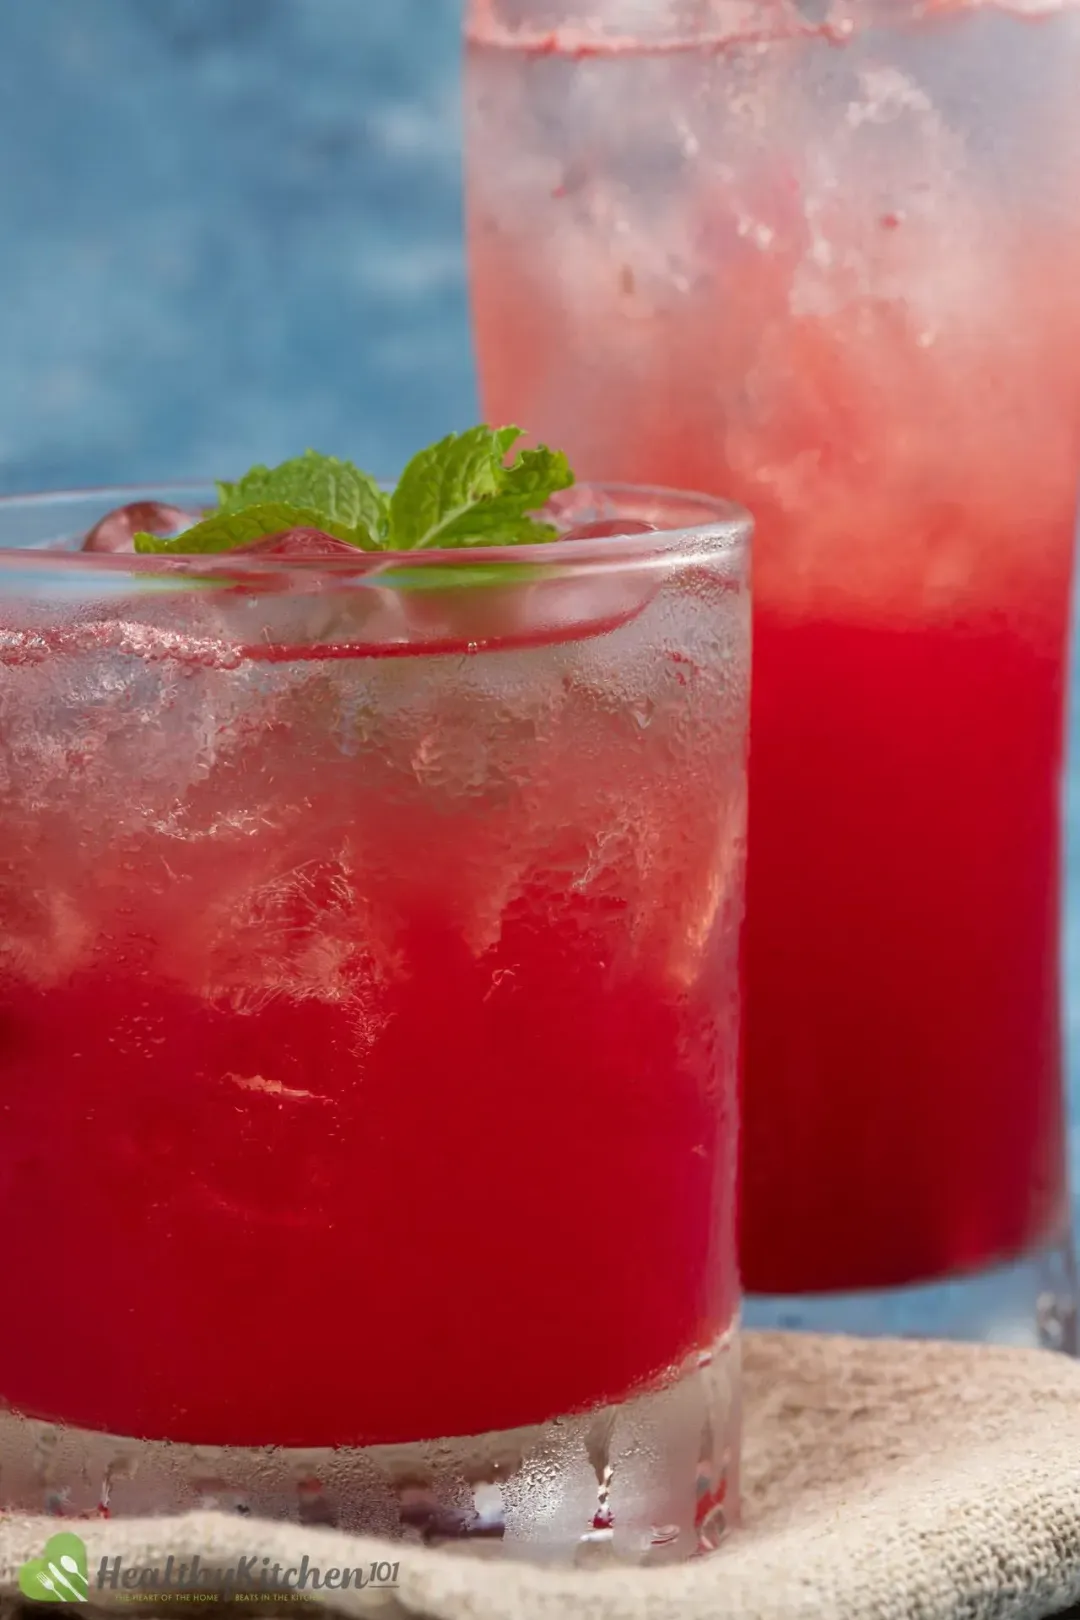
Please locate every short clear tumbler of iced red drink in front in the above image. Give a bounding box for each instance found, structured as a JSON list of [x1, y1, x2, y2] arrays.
[[0, 476, 750, 1562]]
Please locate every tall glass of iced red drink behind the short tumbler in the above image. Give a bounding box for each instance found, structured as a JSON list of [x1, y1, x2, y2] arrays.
[[468, 0, 1080, 1345]]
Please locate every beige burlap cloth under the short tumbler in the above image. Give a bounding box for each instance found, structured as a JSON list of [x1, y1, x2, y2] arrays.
[[0, 1333, 1080, 1620]]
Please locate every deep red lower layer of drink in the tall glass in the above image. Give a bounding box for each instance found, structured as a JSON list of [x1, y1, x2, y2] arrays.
[[742, 614, 1067, 1293]]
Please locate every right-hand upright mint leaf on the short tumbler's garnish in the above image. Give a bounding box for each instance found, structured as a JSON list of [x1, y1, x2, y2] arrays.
[[387, 426, 573, 551]]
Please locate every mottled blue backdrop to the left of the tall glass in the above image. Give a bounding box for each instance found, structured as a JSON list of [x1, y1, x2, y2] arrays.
[[0, 0, 476, 491]]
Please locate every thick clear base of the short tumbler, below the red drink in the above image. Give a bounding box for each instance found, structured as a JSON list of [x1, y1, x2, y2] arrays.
[[0, 1328, 738, 1563]]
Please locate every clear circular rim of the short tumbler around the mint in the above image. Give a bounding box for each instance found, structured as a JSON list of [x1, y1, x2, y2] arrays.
[[0, 480, 753, 575]]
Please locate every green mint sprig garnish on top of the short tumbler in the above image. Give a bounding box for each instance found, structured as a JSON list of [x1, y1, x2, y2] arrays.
[[134, 426, 573, 556]]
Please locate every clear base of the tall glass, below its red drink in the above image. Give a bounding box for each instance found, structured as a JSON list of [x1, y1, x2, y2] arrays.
[[743, 1239, 1078, 1356]]
